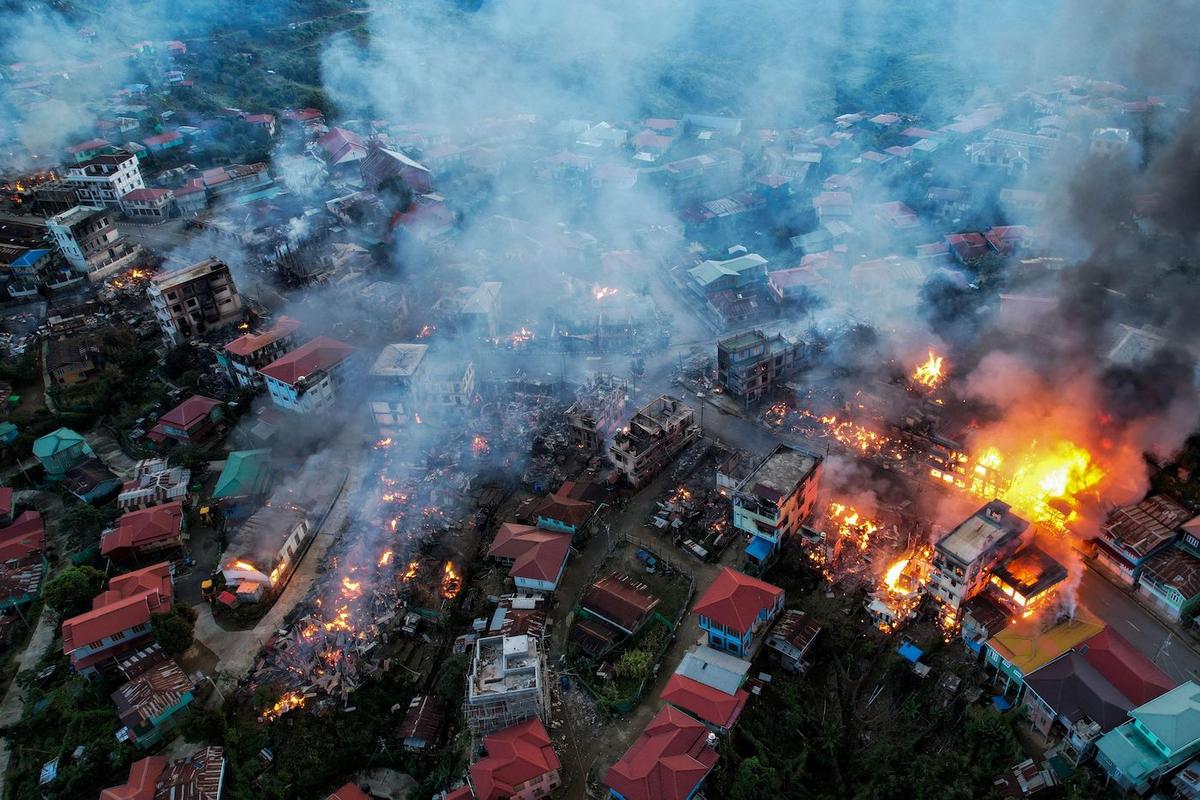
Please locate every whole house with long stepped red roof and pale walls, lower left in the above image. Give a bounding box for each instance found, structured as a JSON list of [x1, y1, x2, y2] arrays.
[[62, 561, 175, 675]]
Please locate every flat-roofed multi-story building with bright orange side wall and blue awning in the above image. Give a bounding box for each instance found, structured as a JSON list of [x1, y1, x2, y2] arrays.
[[732, 444, 822, 563]]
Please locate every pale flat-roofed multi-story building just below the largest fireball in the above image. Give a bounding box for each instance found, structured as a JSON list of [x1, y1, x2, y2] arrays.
[[929, 500, 1030, 614]]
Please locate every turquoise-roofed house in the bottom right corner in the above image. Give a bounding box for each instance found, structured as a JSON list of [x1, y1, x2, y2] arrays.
[[1096, 680, 1200, 794]]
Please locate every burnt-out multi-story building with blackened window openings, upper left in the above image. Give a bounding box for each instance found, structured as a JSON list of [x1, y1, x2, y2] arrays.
[[146, 258, 241, 344]]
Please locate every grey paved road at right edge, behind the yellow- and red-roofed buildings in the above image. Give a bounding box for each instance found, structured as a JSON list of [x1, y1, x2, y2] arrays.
[[1079, 566, 1200, 682]]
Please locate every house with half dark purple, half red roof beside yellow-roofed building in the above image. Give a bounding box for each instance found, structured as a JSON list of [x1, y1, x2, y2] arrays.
[[1024, 628, 1176, 764]]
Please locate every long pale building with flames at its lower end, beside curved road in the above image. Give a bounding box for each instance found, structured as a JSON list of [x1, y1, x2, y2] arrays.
[[221, 505, 314, 602]]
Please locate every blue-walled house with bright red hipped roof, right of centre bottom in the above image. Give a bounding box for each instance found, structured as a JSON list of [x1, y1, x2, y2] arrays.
[[692, 567, 784, 658]]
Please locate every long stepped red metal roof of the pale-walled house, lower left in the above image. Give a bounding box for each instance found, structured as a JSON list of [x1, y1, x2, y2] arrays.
[[62, 561, 174, 654]]
